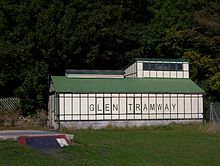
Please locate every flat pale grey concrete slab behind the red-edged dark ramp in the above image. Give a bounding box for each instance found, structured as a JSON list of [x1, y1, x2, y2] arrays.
[[0, 130, 73, 141]]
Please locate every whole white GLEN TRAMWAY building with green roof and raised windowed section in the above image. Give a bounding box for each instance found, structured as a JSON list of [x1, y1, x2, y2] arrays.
[[48, 59, 204, 129]]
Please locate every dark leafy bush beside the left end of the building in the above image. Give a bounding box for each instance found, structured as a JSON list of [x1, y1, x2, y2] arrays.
[[17, 62, 49, 115]]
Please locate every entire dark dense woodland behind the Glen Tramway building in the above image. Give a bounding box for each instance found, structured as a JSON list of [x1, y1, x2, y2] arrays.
[[0, 0, 220, 114]]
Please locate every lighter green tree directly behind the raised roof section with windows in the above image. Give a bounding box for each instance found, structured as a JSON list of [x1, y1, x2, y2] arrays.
[[143, 0, 198, 58]]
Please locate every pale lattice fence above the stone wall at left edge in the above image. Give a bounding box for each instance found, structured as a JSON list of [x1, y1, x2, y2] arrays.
[[0, 97, 20, 110]]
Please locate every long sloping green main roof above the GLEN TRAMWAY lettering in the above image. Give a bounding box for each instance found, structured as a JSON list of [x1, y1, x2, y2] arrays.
[[52, 76, 204, 93]]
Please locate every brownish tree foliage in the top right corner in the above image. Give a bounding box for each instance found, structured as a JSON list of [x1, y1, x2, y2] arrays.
[[188, 0, 220, 58]]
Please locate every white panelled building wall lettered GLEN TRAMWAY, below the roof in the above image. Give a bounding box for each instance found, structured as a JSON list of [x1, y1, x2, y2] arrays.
[[50, 93, 203, 127]]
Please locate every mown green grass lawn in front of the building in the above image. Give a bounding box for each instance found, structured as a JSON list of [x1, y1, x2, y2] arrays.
[[0, 125, 220, 166]]
